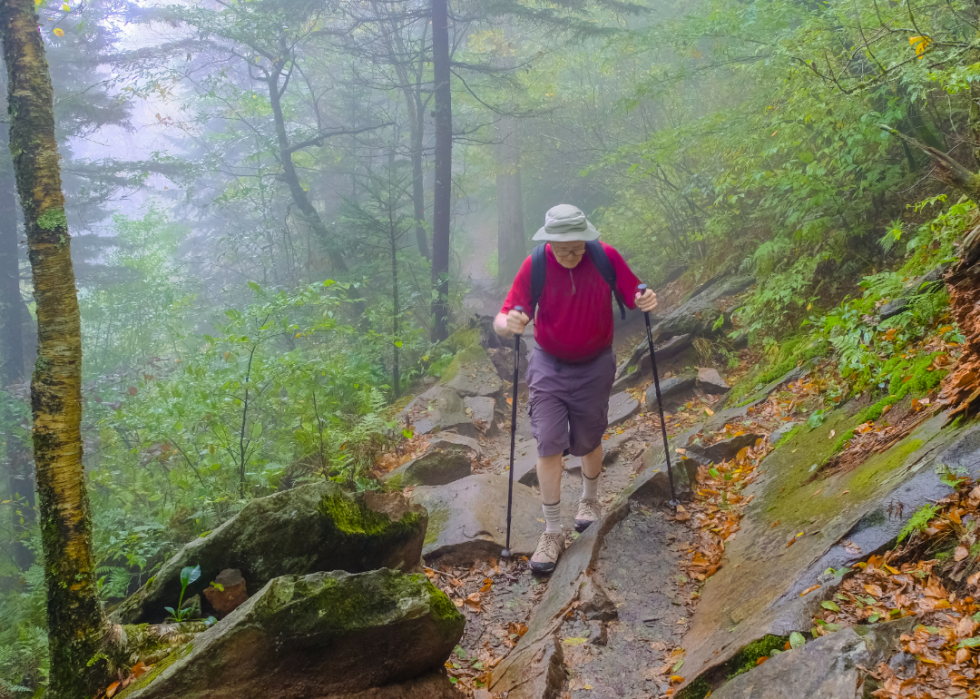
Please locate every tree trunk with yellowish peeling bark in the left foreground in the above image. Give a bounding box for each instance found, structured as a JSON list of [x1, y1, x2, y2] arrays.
[[0, 0, 108, 699]]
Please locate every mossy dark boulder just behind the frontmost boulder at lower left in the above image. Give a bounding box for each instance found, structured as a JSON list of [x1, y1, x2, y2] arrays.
[[111, 481, 428, 624]]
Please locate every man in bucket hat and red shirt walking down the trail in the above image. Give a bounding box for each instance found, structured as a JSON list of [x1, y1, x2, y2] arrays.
[[494, 204, 657, 574]]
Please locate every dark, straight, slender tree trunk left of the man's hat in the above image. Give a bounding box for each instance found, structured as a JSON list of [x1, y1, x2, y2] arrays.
[[432, 0, 453, 342]]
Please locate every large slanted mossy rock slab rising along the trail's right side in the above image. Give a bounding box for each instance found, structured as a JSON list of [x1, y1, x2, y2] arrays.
[[684, 407, 980, 696]]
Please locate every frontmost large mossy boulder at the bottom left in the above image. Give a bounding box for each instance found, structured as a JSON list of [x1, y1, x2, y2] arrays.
[[120, 569, 466, 699]]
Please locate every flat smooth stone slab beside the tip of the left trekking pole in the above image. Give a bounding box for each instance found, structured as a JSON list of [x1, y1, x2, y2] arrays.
[[412, 473, 544, 565]]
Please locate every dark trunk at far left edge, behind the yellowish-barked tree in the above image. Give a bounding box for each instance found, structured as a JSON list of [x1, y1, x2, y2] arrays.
[[0, 163, 35, 570]]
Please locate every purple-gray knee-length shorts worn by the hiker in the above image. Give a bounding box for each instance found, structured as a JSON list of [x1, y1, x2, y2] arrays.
[[527, 348, 616, 456]]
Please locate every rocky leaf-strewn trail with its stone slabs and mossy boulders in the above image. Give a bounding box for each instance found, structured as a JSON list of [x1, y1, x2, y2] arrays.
[[97, 278, 980, 699]]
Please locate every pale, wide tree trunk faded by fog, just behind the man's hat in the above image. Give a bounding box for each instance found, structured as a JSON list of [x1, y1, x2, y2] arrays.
[[495, 117, 527, 287]]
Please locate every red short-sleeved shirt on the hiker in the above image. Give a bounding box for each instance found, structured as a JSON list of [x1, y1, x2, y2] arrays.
[[500, 243, 640, 364]]
